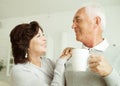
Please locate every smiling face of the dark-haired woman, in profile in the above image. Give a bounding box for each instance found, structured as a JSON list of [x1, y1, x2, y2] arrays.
[[28, 29, 46, 56]]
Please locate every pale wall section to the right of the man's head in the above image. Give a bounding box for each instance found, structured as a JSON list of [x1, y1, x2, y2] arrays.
[[105, 6, 120, 46]]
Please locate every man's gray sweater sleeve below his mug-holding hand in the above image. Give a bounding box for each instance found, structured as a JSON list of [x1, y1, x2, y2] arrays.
[[104, 69, 120, 86]]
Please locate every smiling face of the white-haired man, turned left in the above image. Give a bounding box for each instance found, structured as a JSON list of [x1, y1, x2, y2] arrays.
[[72, 8, 94, 44]]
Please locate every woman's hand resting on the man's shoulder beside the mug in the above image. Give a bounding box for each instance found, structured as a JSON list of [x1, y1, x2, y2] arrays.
[[60, 47, 73, 59]]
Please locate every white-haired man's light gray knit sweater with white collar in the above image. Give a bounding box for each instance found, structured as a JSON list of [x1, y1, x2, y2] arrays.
[[65, 41, 120, 86]]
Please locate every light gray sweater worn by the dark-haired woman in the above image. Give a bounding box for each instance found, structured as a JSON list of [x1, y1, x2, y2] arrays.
[[11, 58, 66, 86]]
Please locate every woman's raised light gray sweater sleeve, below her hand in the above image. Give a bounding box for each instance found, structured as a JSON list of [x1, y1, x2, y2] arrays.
[[51, 58, 67, 86]]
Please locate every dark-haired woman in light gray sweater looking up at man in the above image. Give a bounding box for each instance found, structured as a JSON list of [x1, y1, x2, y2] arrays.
[[10, 21, 70, 86]]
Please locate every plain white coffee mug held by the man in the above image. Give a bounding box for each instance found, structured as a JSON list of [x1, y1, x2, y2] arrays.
[[71, 48, 89, 71]]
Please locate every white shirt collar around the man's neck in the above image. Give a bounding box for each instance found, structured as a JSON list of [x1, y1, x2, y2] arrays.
[[82, 39, 109, 51]]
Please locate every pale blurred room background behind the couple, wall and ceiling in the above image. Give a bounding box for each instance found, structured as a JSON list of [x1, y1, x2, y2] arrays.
[[0, 0, 120, 86]]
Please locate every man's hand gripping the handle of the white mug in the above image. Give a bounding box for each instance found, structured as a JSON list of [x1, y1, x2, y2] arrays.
[[88, 55, 112, 77]]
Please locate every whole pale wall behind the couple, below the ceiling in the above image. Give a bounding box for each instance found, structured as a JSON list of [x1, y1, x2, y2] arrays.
[[0, 6, 120, 63]]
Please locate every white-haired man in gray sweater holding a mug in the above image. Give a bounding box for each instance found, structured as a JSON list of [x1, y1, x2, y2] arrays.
[[65, 5, 120, 86]]
